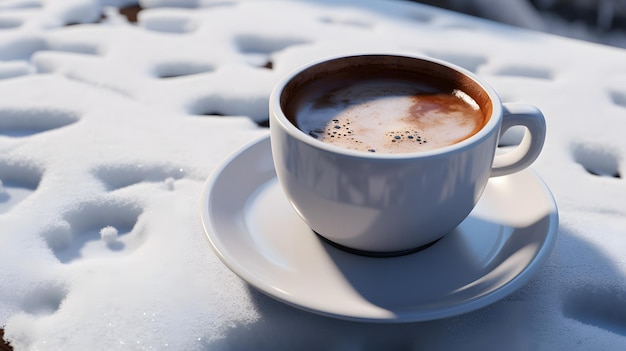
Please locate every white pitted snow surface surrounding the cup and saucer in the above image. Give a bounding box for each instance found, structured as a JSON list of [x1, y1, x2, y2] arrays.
[[0, 0, 626, 350]]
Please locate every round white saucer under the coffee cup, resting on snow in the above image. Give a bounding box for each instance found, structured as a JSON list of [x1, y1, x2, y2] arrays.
[[202, 137, 558, 322]]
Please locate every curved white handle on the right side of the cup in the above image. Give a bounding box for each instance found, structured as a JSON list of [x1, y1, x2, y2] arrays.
[[491, 103, 546, 177]]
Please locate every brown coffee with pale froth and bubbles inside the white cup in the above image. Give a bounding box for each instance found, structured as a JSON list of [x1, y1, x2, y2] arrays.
[[292, 77, 486, 153]]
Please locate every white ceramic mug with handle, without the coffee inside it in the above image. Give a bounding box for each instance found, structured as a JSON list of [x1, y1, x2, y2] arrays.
[[269, 54, 546, 256]]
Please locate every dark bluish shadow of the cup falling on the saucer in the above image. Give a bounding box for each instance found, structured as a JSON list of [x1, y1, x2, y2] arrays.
[[314, 215, 550, 319]]
